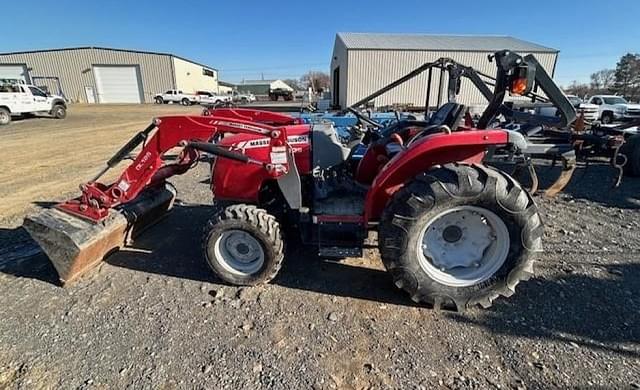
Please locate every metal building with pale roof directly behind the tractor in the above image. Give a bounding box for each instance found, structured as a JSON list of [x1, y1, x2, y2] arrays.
[[331, 33, 558, 108]]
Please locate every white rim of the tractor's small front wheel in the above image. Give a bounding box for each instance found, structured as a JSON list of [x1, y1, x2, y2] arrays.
[[214, 230, 264, 276]]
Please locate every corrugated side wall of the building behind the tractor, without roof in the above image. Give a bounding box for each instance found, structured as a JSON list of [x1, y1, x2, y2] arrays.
[[340, 50, 557, 107]]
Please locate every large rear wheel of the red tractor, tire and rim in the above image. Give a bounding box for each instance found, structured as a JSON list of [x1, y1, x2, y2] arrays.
[[379, 164, 543, 311]]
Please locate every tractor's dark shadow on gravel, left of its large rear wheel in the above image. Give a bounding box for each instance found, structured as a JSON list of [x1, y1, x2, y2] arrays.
[[0, 202, 413, 306]]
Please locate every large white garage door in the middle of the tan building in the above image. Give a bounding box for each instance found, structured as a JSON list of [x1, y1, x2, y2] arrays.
[[93, 66, 142, 103]]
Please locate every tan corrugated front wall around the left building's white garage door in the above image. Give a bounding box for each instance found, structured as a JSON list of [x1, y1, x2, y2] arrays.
[[0, 48, 175, 103]]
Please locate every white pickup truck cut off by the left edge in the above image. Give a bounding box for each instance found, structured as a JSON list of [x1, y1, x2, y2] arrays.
[[0, 83, 67, 125]]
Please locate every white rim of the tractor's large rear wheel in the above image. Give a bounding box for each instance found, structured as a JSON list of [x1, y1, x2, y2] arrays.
[[417, 206, 510, 287]]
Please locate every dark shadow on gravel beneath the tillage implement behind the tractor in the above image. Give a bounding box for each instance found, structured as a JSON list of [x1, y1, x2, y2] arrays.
[[518, 163, 640, 209]]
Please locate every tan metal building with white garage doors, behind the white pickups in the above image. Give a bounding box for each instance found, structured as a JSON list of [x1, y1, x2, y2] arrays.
[[0, 47, 218, 103]]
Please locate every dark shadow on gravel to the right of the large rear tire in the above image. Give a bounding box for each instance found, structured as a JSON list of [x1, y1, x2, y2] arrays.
[[451, 259, 640, 358]]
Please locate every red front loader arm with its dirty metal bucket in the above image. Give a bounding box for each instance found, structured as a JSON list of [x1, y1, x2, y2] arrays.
[[23, 111, 289, 285]]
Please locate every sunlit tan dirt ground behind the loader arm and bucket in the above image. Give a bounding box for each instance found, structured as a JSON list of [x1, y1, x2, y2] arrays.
[[0, 105, 200, 225]]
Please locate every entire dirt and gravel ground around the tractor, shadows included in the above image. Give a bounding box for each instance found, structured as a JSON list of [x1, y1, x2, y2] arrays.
[[0, 106, 640, 389]]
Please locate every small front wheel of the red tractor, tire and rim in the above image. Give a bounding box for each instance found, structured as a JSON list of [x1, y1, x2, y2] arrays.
[[202, 204, 284, 286]]
